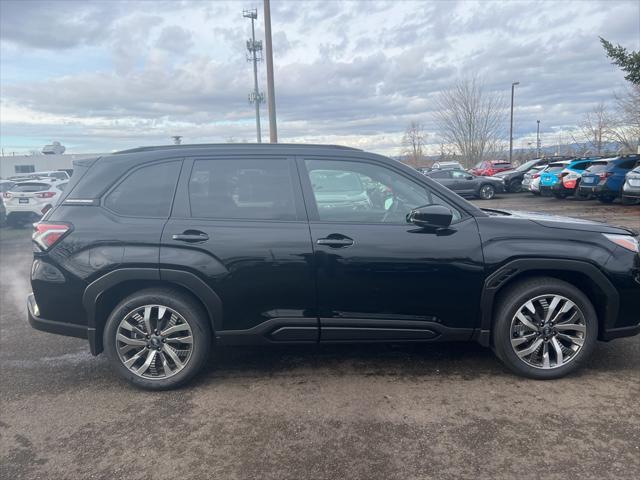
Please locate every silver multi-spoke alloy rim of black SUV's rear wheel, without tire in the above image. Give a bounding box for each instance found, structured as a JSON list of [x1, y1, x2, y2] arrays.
[[116, 305, 193, 380]]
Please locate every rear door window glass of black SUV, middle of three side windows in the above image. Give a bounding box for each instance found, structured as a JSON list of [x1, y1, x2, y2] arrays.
[[189, 159, 297, 220]]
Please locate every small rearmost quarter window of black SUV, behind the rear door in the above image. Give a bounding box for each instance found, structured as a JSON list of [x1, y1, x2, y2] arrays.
[[104, 162, 181, 218]]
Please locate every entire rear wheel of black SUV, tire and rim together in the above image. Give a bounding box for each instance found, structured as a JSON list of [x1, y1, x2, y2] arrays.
[[103, 288, 212, 390]]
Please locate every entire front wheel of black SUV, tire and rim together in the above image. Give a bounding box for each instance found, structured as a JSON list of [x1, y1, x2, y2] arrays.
[[492, 277, 598, 380]]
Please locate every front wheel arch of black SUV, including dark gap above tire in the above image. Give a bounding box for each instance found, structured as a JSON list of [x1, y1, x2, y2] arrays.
[[475, 258, 619, 346]]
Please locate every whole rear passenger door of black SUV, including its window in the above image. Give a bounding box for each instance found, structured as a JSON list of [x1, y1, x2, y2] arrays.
[[160, 155, 318, 343]]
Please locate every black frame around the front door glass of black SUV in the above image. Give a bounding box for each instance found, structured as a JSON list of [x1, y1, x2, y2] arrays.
[[296, 155, 472, 227]]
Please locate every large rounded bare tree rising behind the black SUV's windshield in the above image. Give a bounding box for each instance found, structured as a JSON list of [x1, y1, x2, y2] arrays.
[[434, 77, 506, 166]]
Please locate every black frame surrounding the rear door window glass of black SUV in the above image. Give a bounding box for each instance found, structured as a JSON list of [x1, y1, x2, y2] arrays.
[[178, 153, 307, 223]]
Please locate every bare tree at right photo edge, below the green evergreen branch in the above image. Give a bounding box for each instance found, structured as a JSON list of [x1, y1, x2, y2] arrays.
[[610, 85, 640, 153]]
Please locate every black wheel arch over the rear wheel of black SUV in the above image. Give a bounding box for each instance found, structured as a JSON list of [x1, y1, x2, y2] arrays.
[[82, 268, 222, 355]]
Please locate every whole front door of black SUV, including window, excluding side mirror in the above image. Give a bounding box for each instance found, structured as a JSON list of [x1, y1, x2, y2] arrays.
[[299, 158, 483, 341]]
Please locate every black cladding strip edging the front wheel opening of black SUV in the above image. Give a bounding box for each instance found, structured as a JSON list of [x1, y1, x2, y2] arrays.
[[474, 258, 620, 346]]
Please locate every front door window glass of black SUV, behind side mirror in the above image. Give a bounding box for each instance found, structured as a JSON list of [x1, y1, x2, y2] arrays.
[[305, 160, 461, 223]]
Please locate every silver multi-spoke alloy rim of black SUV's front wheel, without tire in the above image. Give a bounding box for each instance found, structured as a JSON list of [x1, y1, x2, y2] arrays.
[[510, 294, 587, 370]]
